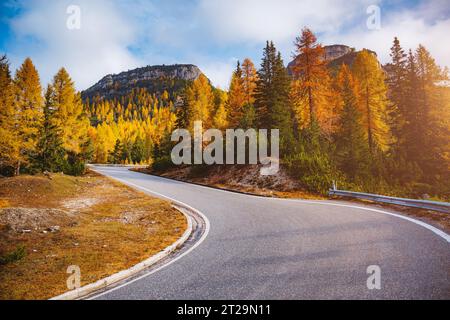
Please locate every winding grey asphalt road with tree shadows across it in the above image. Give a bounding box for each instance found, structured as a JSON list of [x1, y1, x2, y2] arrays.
[[90, 167, 450, 299]]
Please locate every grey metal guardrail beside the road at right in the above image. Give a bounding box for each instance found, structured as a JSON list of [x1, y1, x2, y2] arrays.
[[329, 188, 450, 213]]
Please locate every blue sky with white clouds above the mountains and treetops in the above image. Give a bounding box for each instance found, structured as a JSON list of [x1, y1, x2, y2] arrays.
[[0, 0, 450, 90]]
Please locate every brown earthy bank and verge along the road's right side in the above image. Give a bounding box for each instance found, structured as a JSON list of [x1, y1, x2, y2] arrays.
[[139, 166, 450, 233]]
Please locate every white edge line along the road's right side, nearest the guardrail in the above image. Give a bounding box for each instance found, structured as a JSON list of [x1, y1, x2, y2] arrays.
[[110, 171, 450, 243]]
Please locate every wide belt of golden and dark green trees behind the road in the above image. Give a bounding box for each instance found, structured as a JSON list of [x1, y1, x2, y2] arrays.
[[0, 28, 450, 200]]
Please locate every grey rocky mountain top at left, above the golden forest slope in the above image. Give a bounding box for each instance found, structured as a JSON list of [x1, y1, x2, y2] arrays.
[[82, 64, 202, 99]]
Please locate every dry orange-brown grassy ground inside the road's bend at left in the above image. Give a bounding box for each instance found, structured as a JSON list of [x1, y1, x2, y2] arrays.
[[0, 172, 187, 299]]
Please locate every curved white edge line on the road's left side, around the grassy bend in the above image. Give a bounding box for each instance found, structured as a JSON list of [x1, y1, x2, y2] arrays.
[[87, 172, 210, 300]]
